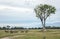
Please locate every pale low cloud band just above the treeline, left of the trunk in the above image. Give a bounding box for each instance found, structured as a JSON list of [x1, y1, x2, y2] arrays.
[[0, 22, 41, 28]]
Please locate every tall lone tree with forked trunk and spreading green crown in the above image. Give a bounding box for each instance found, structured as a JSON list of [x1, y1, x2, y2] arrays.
[[34, 4, 56, 39]]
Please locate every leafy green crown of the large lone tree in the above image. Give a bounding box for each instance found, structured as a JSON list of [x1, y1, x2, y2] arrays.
[[34, 4, 56, 20]]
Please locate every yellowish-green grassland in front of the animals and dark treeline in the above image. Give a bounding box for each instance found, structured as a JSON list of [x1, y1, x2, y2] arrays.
[[0, 29, 60, 39]]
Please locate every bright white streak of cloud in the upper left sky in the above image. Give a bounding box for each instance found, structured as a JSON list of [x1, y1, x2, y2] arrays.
[[0, 5, 32, 12]]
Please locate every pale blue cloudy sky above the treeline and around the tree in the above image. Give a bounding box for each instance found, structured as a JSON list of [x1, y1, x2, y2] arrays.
[[0, 0, 60, 27]]
